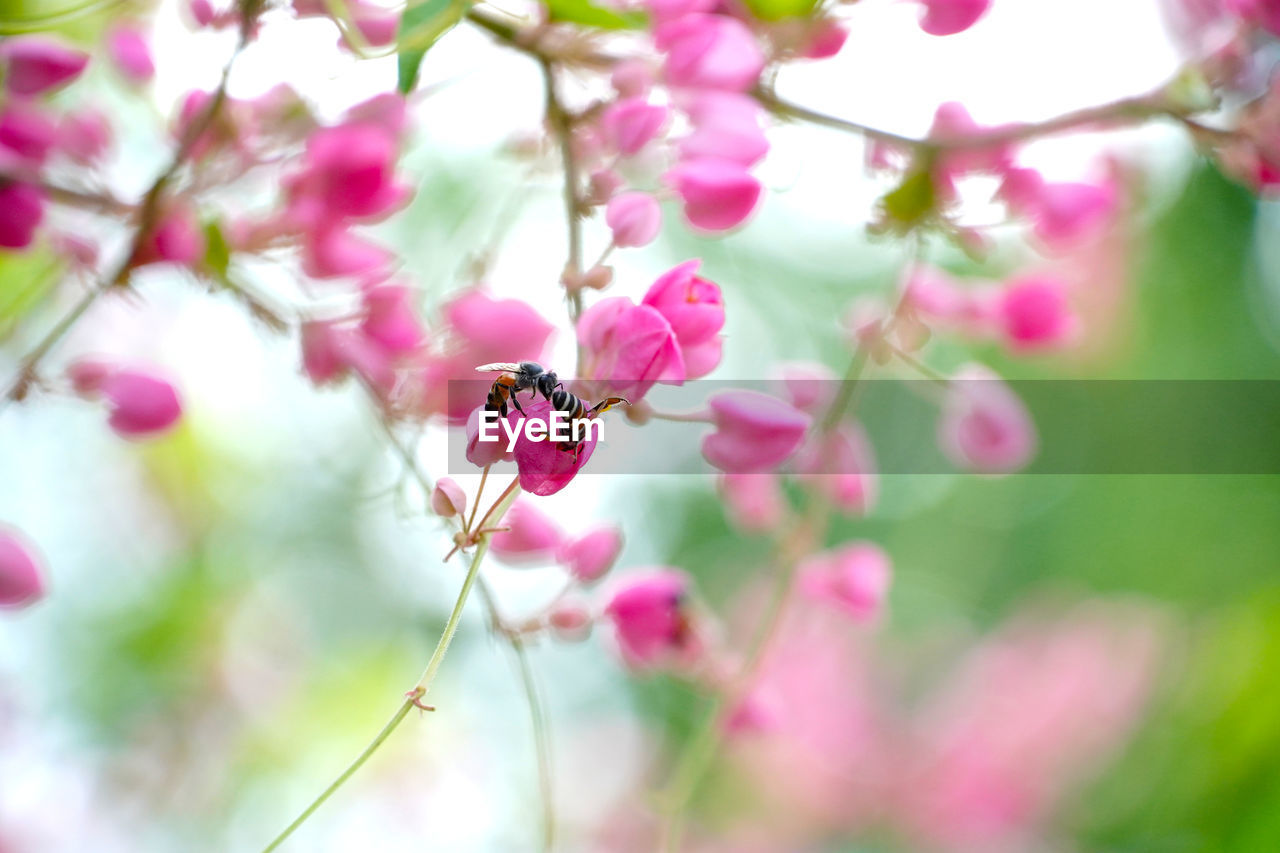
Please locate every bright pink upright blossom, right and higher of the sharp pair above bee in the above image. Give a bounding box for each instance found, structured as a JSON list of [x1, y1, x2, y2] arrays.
[[641, 259, 724, 379]]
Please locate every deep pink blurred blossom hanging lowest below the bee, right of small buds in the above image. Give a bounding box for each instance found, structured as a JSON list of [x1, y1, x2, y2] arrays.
[[604, 569, 700, 669]]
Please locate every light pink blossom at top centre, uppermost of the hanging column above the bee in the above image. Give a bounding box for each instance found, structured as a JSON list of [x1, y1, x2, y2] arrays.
[[654, 13, 764, 92]]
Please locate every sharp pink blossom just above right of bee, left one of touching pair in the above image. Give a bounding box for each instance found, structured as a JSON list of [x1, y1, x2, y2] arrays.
[[577, 296, 685, 402]]
